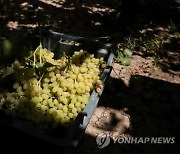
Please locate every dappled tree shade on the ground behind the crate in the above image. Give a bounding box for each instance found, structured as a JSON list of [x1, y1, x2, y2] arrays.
[[0, 0, 180, 73]]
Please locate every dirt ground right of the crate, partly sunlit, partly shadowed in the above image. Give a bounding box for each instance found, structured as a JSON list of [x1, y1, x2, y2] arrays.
[[78, 55, 180, 154]]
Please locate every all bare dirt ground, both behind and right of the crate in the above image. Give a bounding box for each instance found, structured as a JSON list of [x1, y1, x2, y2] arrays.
[[0, 0, 180, 154]]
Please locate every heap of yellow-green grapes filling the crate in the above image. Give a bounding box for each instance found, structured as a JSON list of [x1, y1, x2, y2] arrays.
[[0, 49, 106, 128]]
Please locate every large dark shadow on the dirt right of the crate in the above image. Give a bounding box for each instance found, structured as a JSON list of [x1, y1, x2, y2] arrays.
[[78, 75, 180, 154]]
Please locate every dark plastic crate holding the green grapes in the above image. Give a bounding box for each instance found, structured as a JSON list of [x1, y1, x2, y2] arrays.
[[0, 31, 114, 153]]
